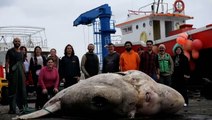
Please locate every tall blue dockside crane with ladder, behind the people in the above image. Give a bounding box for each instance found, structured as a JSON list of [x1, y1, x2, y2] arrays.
[[73, 4, 116, 67]]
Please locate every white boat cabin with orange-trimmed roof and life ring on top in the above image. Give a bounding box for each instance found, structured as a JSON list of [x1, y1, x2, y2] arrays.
[[115, 0, 194, 55]]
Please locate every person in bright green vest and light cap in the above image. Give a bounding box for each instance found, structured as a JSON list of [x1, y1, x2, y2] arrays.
[[158, 44, 174, 86]]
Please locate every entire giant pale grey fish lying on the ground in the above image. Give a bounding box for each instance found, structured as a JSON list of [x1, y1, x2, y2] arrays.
[[13, 70, 184, 119]]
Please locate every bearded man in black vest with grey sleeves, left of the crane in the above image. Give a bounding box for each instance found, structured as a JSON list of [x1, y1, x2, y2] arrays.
[[81, 43, 99, 78]]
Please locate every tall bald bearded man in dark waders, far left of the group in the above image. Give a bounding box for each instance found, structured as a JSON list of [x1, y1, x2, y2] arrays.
[[5, 38, 27, 114]]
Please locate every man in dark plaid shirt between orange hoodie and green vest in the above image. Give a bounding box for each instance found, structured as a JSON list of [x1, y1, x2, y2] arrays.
[[139, 40, 160, 81]]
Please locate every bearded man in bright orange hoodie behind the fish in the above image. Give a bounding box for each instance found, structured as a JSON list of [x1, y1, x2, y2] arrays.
[[120, 41, 140, 71]]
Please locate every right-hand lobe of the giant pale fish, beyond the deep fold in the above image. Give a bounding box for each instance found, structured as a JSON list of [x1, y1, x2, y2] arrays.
[[120, 70, 185, 115]]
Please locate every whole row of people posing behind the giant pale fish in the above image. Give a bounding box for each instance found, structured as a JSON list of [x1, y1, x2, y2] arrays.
[[5, 38, 189, 113]]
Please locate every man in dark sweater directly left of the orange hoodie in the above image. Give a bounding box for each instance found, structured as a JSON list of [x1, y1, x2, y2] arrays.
[[102, 43, 120, 73]]
